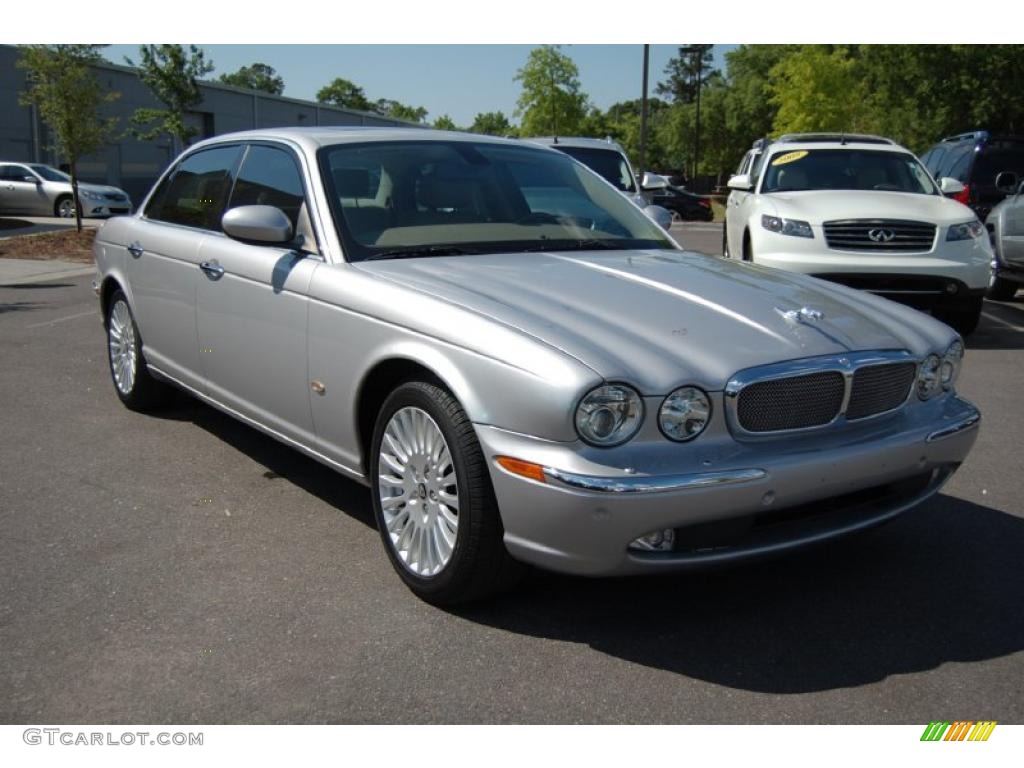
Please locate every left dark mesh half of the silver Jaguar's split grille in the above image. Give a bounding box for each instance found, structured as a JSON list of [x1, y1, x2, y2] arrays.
[[736, 371, 846, 432]]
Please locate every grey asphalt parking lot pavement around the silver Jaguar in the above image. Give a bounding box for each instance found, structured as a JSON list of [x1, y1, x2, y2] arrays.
[[0, 225, 1024, 720]]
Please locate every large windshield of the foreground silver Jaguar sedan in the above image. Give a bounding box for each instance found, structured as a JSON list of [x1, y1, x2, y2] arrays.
[[319, 141, 674, 261]]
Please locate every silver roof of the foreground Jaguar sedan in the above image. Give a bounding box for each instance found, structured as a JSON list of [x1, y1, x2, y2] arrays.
[[189, 125, 548, 152]]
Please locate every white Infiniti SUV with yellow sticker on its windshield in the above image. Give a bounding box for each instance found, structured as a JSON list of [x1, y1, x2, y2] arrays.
[[723, 133, 993, 334]]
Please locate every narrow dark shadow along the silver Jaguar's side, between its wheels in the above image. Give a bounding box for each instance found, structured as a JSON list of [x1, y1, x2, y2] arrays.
[[152, 391, 377, 529]]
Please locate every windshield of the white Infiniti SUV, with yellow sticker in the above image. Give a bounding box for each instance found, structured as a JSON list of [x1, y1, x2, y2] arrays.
[[761, 150, 938, 195]]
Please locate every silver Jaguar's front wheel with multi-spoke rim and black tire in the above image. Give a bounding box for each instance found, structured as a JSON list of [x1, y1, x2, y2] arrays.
[[370, 381, 520, 605]]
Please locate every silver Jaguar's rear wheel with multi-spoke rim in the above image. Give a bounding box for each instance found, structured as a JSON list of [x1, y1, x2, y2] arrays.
[[105, 289, 167, 412]]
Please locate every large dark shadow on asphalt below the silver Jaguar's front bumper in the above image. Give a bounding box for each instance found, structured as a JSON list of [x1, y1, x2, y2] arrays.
[[454, 496, 1024, 693]]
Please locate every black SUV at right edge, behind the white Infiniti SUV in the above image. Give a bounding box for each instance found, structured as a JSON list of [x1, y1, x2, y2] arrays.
[[921, 131, 1024, 221]]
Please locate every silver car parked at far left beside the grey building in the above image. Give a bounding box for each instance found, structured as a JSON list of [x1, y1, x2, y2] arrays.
[[0, 163, 132, 218]]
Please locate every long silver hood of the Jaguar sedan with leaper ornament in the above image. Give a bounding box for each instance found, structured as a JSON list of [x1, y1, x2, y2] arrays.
[[357, 250, 953, 395]]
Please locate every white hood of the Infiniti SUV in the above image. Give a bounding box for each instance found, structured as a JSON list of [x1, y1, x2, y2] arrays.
[[762, 189, 977, 224]]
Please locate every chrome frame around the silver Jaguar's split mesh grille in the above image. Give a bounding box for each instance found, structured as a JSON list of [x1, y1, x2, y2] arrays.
[[723, 349, 922, 440]]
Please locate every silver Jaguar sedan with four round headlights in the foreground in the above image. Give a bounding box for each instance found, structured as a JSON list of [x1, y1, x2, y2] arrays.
[[95, 128, 980, 604]]
